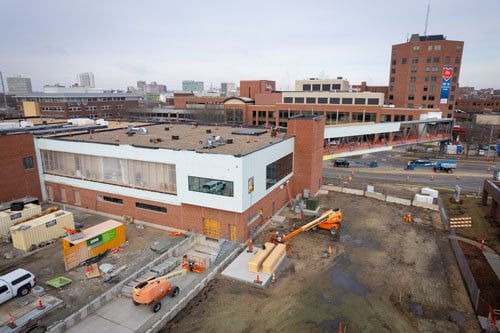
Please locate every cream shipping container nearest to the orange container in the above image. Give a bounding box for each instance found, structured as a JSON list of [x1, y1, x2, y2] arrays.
[[10, 210, 75, 251]]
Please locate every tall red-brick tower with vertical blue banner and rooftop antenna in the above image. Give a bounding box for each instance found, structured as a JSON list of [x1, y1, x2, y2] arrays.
[[386, 34, 464, 118]]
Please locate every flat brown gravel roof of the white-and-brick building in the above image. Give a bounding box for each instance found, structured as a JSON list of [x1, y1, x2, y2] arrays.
[[56, 124, 285, 155]]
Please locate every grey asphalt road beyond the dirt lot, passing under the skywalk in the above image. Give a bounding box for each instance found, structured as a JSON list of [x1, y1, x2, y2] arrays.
[[323, 151, 500, 193]]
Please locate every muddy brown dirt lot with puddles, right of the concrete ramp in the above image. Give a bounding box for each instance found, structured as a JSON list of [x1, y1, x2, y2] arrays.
[[162, 193, 479, 332]]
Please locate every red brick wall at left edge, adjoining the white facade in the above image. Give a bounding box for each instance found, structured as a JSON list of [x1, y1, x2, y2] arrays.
[[0, 134, 42, 202]]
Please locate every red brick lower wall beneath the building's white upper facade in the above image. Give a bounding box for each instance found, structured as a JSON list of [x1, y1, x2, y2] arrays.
[[45, 182, 288, 241]]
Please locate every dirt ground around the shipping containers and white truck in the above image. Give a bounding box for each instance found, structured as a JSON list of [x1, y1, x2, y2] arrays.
[[0, 207, 182, 324]]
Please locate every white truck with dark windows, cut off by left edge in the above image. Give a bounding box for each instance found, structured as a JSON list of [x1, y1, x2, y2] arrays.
[[0, 268, 36, 304]]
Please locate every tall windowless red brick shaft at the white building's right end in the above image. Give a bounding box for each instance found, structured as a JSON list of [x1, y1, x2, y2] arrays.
[[287, 117, 325, 195]]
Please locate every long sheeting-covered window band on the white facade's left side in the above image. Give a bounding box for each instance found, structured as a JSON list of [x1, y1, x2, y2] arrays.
[[41, 150, 177, 194]]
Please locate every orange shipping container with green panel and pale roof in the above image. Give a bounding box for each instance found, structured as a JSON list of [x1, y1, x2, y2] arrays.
[[62, 220, 126, 271]]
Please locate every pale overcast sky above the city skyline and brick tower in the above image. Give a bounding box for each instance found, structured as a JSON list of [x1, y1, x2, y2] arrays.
[[0, 0, 500, 90]]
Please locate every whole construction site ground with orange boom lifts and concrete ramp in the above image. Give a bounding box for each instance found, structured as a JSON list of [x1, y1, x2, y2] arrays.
[[0, 183, 479, 332]]
